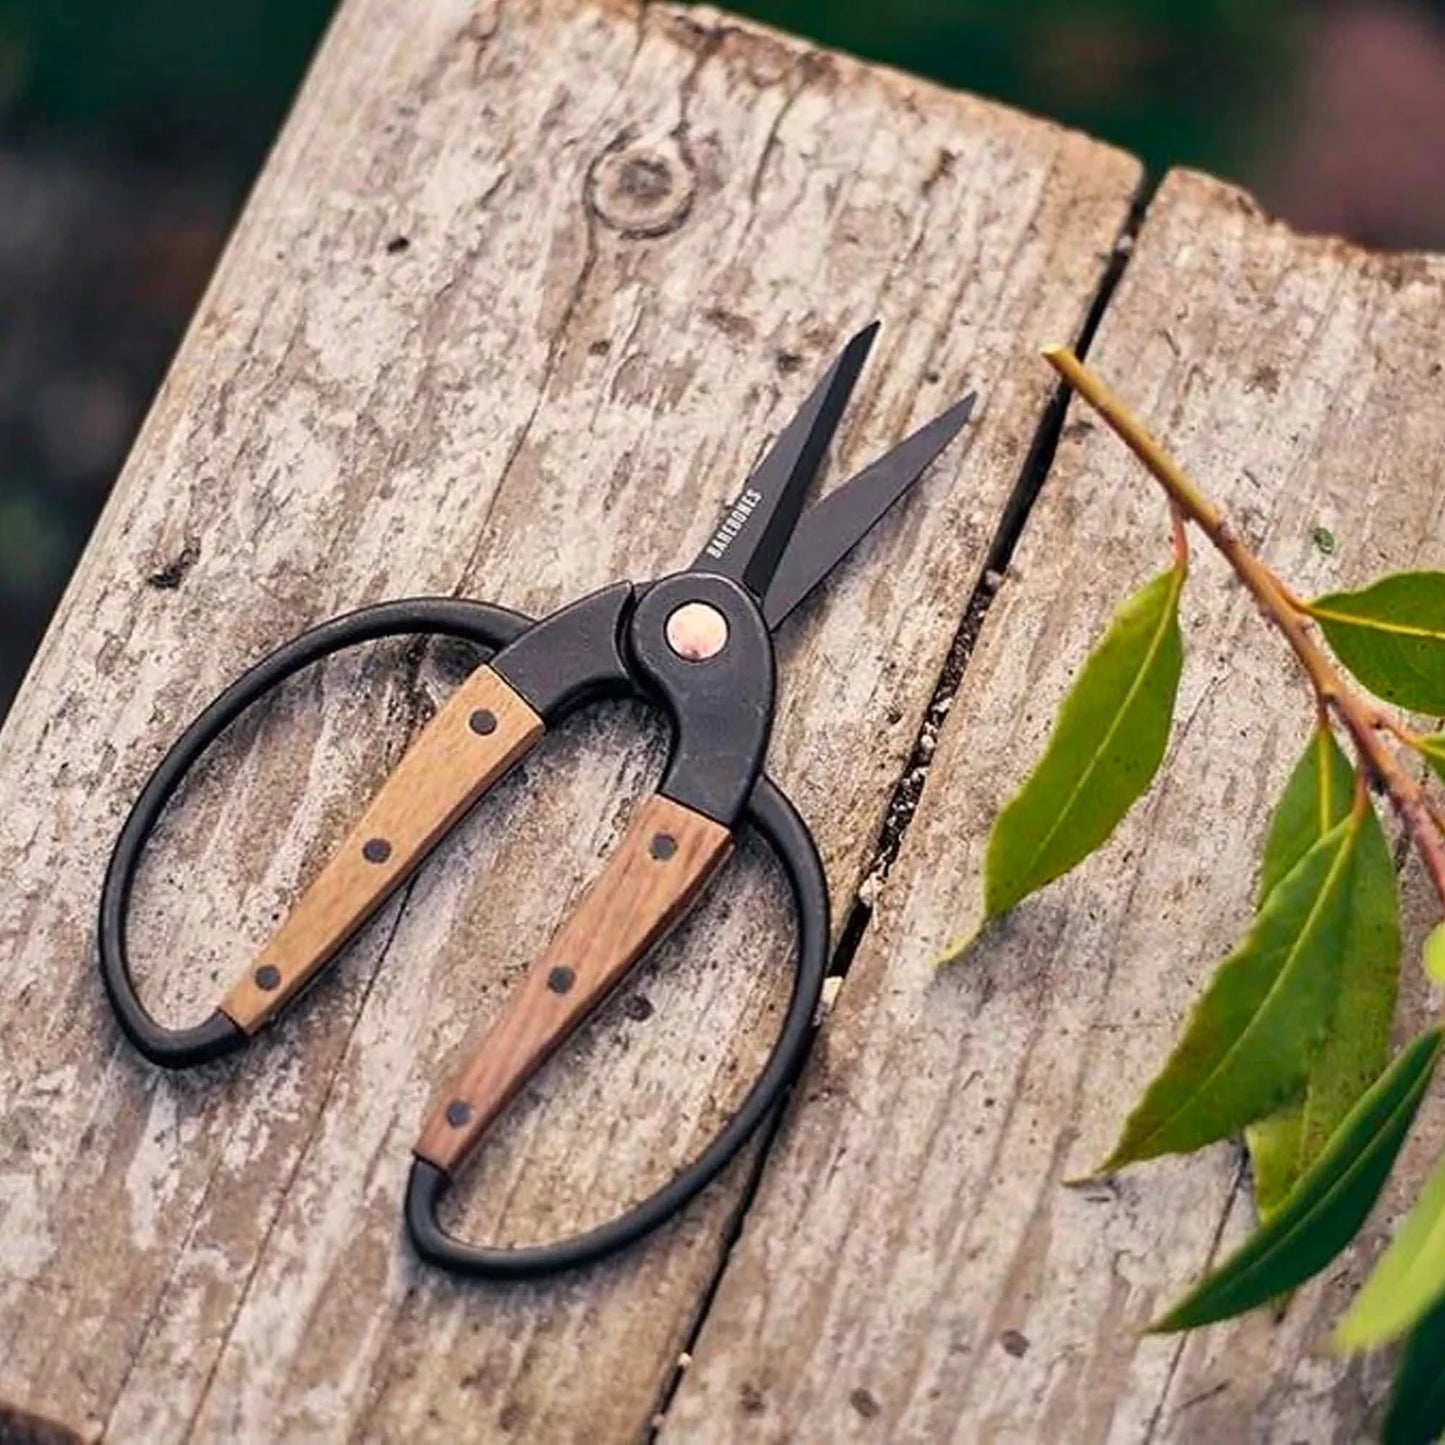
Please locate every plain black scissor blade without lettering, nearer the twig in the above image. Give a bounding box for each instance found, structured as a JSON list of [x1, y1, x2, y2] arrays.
[[763, 392, 978, 631]]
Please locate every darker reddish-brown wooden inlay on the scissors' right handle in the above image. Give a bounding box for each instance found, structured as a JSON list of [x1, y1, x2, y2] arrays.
[[415, 796, 731, 1172]]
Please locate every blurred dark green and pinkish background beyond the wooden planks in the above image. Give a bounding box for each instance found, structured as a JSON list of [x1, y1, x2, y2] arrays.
[[0, 0, 1445, 715]]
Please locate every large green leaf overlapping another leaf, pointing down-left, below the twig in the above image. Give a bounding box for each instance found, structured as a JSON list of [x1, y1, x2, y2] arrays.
[[1101, 818, 1363, 1172]]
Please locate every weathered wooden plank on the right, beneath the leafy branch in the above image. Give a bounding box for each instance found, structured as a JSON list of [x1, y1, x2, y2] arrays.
[[665, 173, 1445, 1442]]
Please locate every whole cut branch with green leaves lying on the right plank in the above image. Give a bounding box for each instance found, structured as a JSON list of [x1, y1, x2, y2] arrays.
[[939, 347, 1445, 1445]]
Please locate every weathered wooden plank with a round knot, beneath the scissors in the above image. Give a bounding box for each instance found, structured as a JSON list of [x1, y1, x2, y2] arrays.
[[0, 0, 1137, 1441]]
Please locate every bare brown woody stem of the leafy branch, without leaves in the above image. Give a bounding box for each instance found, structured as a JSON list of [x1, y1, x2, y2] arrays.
[[1043, 347, 1445, 905]]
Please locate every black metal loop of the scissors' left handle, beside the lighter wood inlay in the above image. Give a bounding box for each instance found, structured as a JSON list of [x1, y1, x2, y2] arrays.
[[98, 597, 532, 1069]]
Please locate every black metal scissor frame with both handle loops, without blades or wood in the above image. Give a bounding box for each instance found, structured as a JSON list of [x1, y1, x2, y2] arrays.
[[98, 572, 828, 1279]]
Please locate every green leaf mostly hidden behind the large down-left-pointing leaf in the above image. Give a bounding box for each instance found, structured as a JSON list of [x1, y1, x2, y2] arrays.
[[1244, 728, 1400, 1220]]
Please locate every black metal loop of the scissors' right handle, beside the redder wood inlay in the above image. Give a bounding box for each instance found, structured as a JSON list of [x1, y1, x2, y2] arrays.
[[406, 775, 828, 1279]]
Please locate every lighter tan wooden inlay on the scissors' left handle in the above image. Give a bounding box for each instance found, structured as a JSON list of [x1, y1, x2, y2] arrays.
[[221, 668, 542, 1033]]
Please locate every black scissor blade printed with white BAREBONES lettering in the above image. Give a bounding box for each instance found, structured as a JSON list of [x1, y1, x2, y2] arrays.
[[692, 321, 879, 600]]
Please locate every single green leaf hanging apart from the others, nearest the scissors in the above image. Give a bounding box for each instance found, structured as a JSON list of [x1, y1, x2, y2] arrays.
[[984, 566, 1183, 918]]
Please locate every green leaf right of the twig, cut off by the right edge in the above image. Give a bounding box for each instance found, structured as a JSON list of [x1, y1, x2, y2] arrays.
[[1309, 572, 1445, 715]]
